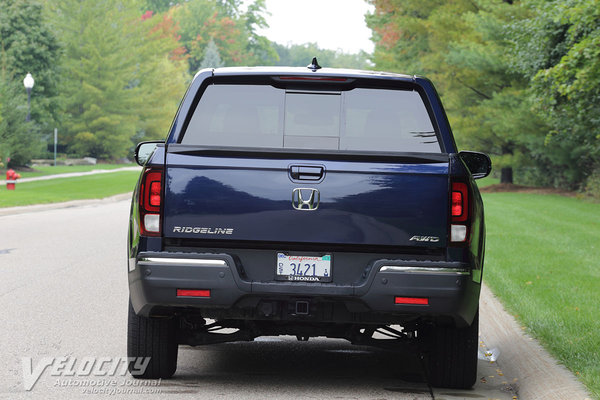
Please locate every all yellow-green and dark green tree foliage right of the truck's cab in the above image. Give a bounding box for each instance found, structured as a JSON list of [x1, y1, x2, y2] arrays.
[[367, 0, 600, 188]]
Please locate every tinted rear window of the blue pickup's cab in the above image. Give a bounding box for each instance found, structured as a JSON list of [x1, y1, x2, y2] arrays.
[[181, 85, 441, 153]]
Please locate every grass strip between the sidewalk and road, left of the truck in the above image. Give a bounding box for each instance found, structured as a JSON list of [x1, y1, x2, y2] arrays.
[[0, 171, 140, 207]]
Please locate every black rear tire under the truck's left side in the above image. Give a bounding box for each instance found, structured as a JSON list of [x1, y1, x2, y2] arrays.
[[127, 301, 177, 379]]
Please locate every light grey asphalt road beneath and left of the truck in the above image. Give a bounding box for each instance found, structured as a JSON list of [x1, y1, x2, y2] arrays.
[[0, 200, 572, 400]]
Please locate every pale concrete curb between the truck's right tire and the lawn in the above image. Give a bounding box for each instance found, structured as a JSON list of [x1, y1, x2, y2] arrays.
[[479, 285, 592, 400]]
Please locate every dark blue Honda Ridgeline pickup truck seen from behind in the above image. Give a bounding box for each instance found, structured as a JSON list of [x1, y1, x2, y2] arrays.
[[128, 60, 491, 388]]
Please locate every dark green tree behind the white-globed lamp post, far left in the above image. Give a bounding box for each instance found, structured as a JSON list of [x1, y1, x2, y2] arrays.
[[0, 0, 60, 165]]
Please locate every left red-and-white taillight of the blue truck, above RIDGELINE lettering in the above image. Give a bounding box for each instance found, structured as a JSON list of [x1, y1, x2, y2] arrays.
[[140, 169, 162, 236]]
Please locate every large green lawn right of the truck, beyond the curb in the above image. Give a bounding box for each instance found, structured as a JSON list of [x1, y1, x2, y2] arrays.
[[483, 193, 600, 398]]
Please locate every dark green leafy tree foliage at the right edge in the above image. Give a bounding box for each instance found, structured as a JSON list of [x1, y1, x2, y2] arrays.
[[513, 0, 600, 189]]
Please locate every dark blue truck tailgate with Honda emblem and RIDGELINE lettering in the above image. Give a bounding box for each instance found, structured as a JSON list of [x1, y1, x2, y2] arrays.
[[163, 145, 448, 247]]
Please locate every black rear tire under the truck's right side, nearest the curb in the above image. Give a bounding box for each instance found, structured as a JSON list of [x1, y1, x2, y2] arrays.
[[425, 310, 479, 389]]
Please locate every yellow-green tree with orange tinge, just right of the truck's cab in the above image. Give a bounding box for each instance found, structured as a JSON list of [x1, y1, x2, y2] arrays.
[[367, 0, 545, 183]]
